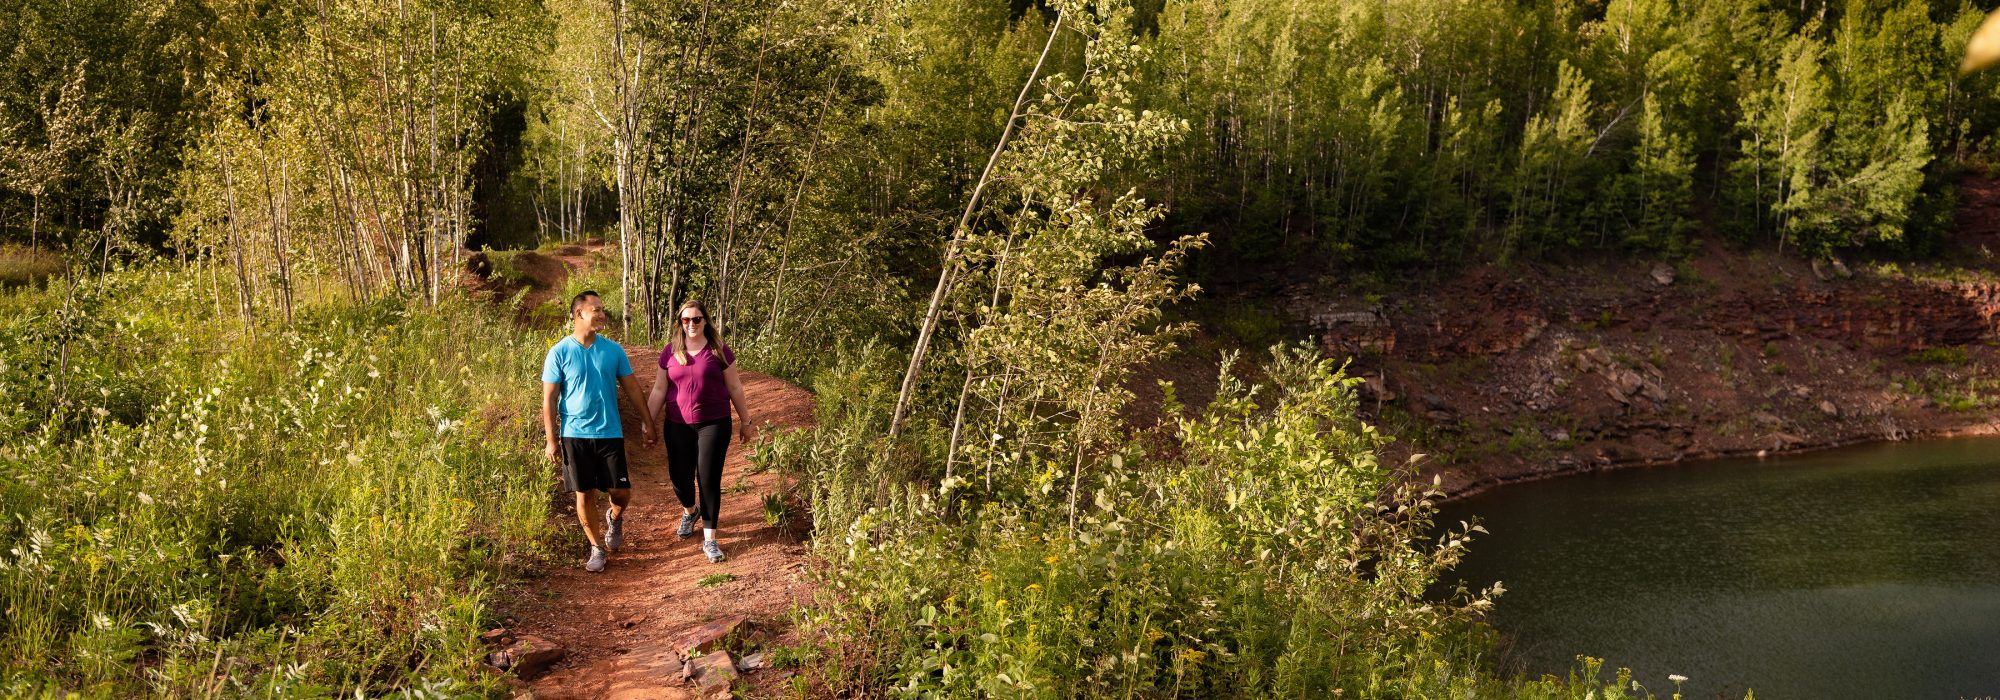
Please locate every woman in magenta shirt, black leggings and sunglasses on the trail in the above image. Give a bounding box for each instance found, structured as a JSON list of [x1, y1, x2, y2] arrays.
[[646, 302, 756, 562]]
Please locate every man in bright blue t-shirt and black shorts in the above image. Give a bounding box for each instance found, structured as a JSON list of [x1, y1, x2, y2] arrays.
[[542, 292, 654, 572]]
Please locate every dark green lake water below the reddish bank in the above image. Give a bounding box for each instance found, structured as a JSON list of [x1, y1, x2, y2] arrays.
[[1440, 438, 2000, 700]]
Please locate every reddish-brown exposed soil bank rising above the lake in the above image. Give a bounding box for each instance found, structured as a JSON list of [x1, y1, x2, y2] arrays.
[[1208, 180, 2000, 496]]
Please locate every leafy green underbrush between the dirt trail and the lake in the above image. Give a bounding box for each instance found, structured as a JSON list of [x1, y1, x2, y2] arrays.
[[764, 348, 1752, 698]]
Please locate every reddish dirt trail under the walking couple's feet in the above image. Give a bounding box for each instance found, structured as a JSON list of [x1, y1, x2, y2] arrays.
[[500, 346, 812, 698]]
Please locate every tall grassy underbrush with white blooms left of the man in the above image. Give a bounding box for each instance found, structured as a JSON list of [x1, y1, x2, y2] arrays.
[[0, 268, 548, 696]]
